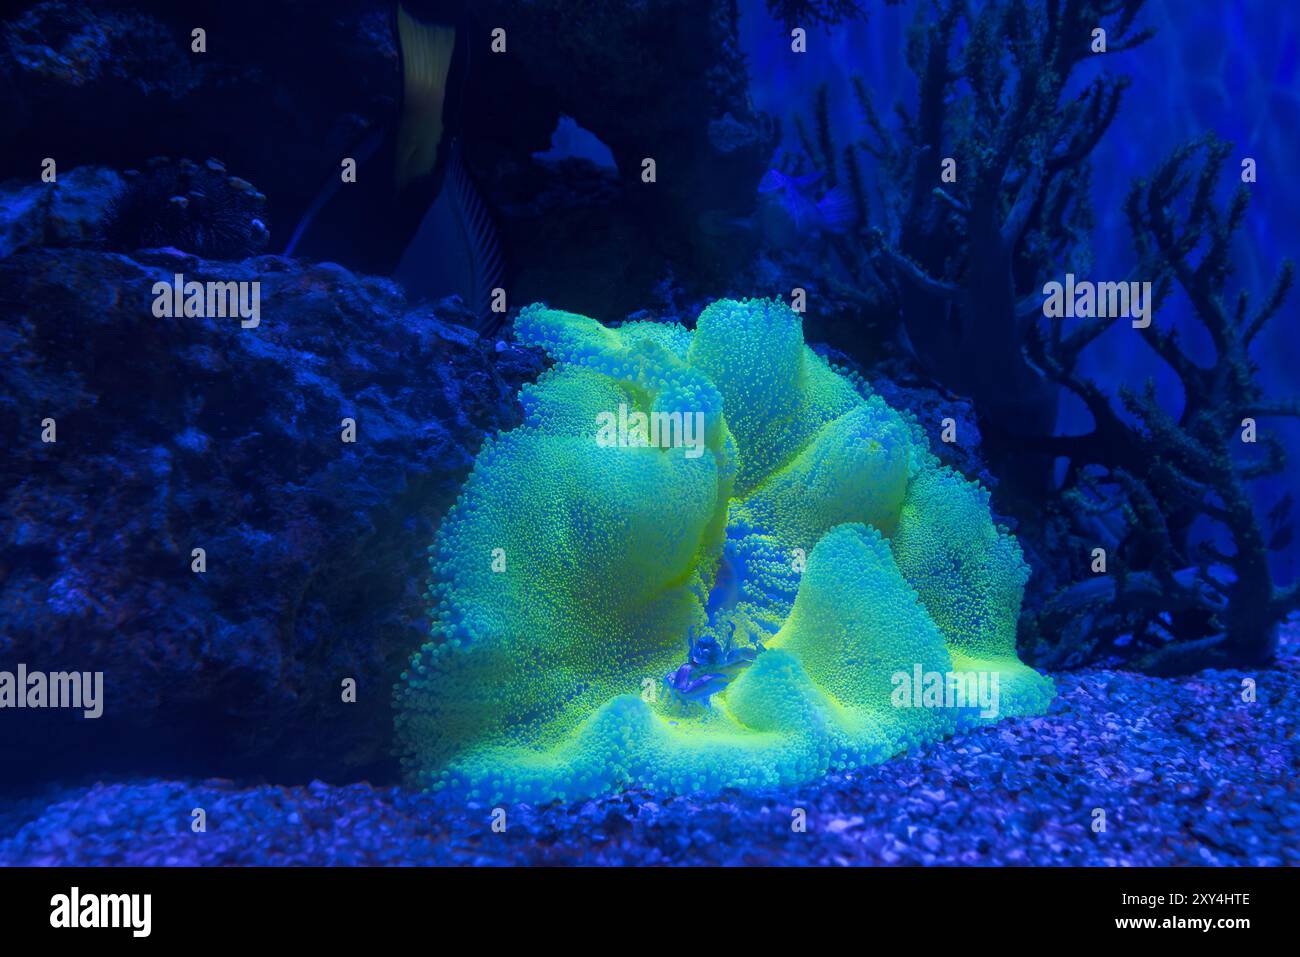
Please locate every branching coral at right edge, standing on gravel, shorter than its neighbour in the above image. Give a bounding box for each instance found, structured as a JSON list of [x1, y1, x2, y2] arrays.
[[1028, 137, 1300, 672]]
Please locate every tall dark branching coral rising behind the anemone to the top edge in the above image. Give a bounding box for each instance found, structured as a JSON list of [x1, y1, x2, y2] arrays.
[[818, 0, 1149, 452]]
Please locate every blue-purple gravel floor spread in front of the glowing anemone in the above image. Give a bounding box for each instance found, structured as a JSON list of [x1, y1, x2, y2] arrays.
[[0, 624, 1300, 866]]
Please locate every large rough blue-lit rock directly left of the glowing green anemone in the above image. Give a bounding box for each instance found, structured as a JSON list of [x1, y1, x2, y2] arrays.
[[0, 248, 537, 788]]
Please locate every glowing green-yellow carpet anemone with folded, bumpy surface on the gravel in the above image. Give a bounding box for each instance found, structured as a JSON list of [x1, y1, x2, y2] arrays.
[[397, 300, 1053, 801]]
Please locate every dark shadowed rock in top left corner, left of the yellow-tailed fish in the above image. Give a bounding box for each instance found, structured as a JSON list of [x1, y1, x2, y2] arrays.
[[0, 0, 399, 251]]
